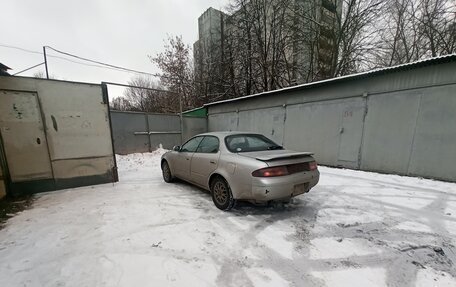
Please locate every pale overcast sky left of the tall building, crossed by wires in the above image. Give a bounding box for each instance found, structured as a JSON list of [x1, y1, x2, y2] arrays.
[[0, 0, 229, 97]]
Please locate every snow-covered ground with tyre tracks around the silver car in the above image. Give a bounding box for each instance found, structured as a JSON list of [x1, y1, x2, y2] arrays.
[[0, 150, 456, 287]]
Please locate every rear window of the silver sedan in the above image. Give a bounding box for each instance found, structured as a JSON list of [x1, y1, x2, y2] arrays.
[[225, 134, 282, 153]]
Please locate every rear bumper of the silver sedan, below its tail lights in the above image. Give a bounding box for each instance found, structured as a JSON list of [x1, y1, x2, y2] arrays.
[[251, 170, 320, 202]]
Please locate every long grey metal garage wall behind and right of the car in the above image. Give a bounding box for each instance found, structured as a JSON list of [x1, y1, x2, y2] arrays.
[[208, 61, 456, 181]]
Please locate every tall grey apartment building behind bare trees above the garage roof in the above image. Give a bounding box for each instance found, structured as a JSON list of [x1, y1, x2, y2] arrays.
[[194, 0, 342, 100]]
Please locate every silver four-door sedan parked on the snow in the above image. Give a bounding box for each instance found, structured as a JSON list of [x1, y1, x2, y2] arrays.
[[161, 132, 320, 210]]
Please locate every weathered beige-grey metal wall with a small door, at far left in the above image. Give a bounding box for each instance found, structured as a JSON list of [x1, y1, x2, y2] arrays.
[[0, 77, 117, 197]]
